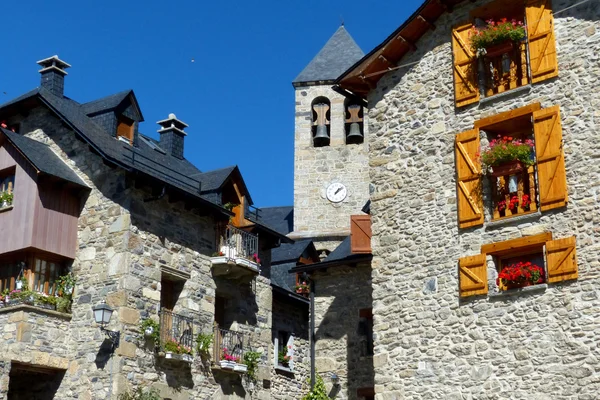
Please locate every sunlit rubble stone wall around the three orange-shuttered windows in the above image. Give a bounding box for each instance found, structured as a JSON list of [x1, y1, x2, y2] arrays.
[[369, 0, 600, 400]]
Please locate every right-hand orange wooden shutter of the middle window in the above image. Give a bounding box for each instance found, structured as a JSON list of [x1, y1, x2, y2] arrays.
[[533, 106, 568, 211]]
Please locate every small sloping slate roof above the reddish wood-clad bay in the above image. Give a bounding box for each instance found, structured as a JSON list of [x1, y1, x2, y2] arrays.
[[0, 128, 89, 189]]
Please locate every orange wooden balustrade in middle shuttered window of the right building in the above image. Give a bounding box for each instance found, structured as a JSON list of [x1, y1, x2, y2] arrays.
[[490, 166, 537, 220]]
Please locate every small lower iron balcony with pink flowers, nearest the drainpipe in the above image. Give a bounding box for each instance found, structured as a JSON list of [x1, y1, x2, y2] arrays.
[[213, 325, 248, 373]]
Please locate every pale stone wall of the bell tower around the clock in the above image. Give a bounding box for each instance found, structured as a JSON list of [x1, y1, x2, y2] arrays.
[[291, 86, 369, 251]]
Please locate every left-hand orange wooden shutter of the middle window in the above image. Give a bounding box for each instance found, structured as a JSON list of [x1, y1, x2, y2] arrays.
[[454, 129, 483, 228]]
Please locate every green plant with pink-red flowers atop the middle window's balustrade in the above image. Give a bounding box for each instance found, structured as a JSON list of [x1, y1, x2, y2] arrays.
[[481, 135, 534, 177]]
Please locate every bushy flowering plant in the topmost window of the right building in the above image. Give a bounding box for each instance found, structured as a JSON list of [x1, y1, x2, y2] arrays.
[[470, 18, 527, 57]]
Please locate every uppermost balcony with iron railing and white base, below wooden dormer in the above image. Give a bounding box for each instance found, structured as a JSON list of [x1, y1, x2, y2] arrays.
[[210, 225, 260, 279]]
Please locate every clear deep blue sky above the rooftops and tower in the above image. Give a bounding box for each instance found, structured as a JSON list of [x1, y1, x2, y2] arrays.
[[0, 0, 422, 206]]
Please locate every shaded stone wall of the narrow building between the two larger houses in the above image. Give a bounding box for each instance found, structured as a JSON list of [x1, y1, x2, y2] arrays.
[[312, 265, 373, 400]]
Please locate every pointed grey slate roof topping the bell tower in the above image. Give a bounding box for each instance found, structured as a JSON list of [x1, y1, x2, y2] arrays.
[[293, 25, 365, 85]]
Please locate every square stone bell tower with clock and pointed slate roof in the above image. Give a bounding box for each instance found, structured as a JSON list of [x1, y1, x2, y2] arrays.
[[290, 25, 369, 253]]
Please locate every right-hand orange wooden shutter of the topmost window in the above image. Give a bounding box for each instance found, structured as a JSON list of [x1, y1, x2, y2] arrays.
[[525, 0, 558, 83]]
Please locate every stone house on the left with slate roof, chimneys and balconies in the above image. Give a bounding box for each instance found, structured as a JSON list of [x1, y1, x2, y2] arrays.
[[0, 56, 308, 400]]
